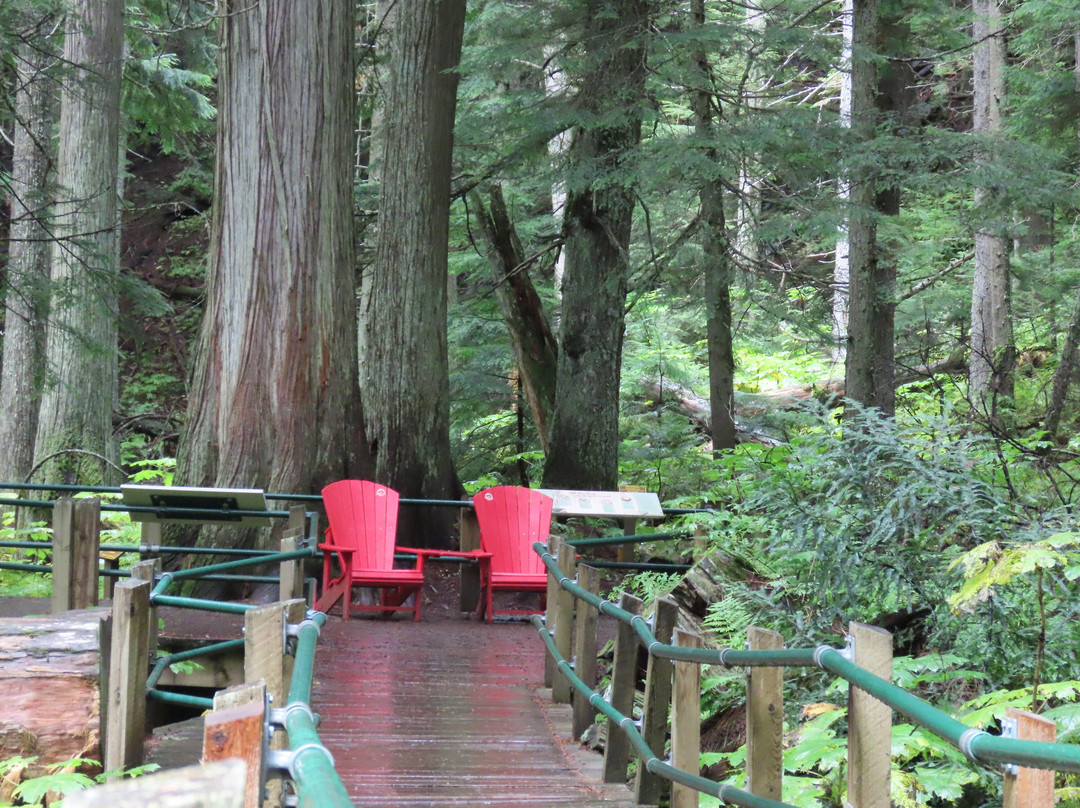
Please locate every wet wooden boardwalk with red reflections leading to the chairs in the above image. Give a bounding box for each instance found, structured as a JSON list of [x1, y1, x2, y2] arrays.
[[312, 616, 633, 808]]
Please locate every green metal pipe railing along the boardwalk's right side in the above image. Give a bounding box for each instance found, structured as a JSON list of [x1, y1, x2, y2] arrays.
[[531, 535, 1080, 808]]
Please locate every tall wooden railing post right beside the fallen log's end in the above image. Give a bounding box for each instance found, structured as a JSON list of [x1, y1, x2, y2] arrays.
[[104, 580, 150, 771]]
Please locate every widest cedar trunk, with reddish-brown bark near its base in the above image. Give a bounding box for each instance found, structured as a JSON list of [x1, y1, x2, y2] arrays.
[[179, 0, 365, 547]]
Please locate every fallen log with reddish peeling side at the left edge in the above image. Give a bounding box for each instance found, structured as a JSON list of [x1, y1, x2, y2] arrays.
[[0, 609, 107, 776]]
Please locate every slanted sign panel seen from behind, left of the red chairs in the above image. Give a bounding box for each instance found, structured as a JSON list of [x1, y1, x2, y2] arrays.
[[120, 485, 270, 527]]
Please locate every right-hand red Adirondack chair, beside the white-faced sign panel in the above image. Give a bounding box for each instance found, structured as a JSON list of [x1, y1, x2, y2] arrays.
[[473, 485, 554, 622]]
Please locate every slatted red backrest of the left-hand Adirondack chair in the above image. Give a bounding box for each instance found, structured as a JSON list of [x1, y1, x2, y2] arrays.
[[323, 480, 399, 569]]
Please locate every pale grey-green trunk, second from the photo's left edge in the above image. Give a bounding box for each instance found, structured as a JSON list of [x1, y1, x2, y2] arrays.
[[35, 0, 124, 483]]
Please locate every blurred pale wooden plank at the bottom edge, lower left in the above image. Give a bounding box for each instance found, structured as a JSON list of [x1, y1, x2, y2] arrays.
[[64, 760, 246, 808]]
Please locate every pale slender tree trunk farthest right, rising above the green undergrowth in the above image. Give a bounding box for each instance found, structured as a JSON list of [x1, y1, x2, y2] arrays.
[[968, 0, 1016, 420]]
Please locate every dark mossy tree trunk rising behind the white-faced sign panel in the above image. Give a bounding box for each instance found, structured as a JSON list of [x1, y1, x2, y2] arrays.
[[543, 0, 649, 490]]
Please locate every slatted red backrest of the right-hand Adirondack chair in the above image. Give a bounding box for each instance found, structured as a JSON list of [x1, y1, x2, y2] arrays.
[[473, 485, 554, 575]]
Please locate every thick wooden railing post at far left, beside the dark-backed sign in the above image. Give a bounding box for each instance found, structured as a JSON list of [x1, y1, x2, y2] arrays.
[[51, 497, 102, 615]]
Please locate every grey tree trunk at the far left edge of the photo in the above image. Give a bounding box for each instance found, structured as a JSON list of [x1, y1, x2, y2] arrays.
[[0, 14, 55, 481]]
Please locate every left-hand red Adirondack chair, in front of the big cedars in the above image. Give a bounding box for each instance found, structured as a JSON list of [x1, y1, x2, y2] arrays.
[[315, 480, 430, 620]]
